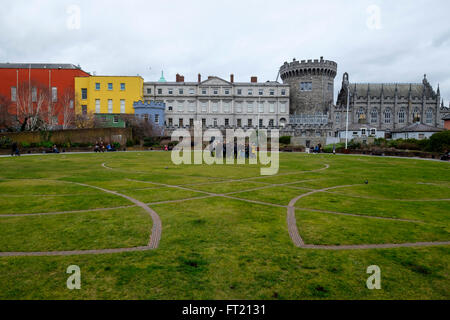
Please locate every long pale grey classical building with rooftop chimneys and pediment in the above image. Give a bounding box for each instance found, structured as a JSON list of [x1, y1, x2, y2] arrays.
[[144, 74, 289, 128]]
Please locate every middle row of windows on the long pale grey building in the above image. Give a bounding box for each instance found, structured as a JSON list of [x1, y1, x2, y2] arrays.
[[167, 103, 287, 113]]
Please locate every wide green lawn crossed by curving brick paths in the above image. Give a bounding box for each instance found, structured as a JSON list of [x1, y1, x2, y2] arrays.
[[0, 152, 450, 299]]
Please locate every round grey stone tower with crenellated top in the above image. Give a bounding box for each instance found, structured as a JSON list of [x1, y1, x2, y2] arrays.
[[280, 57, 337, 115]]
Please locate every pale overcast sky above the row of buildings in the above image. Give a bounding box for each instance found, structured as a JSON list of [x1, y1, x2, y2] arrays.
[[0, 0, 450, 106]]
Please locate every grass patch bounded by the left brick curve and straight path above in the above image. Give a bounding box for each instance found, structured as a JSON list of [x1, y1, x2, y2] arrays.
[[0, 207, 152, 252]]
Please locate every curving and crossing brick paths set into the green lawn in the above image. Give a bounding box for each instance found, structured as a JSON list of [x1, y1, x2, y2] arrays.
[[0, 163, 450, 257]]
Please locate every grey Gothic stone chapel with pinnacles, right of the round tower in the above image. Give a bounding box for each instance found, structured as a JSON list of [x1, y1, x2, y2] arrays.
[[331, 73, 448, 137]]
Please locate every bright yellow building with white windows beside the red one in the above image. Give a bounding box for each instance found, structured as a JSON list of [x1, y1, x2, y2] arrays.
[[75, 76, 144, 114]]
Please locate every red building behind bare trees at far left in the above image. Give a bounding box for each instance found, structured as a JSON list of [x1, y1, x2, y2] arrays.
[[0, 63, 90, 128]]
